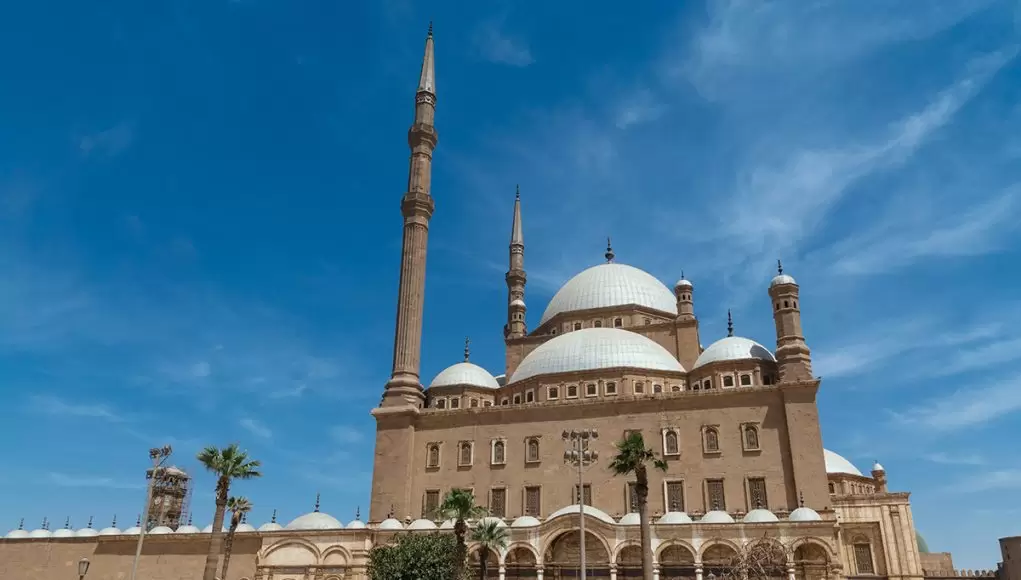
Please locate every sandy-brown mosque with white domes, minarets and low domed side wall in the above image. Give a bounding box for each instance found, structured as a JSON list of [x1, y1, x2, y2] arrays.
[[0, 31, 992, 580]]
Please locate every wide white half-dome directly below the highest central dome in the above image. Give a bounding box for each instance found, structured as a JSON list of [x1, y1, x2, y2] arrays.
[[509, 328, 684, 383]]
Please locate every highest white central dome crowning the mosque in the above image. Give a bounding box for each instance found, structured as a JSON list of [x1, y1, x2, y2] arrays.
[[539, 263, 677, 325]]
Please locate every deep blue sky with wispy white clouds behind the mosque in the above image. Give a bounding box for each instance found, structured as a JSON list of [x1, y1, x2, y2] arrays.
[[0, 0, 1021, 568]]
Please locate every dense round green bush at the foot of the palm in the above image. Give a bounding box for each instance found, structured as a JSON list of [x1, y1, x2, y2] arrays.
[[369, 533, 460, 580]]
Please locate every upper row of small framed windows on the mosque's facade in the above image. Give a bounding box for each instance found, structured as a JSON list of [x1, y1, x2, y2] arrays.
[[426, 423, 761, 469]]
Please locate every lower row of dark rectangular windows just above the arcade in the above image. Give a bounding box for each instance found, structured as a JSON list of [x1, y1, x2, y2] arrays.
[[422, 477, 769, 519]]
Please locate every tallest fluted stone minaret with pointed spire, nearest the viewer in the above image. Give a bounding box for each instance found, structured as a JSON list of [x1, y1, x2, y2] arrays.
[[382, 23, 437, 407]]
